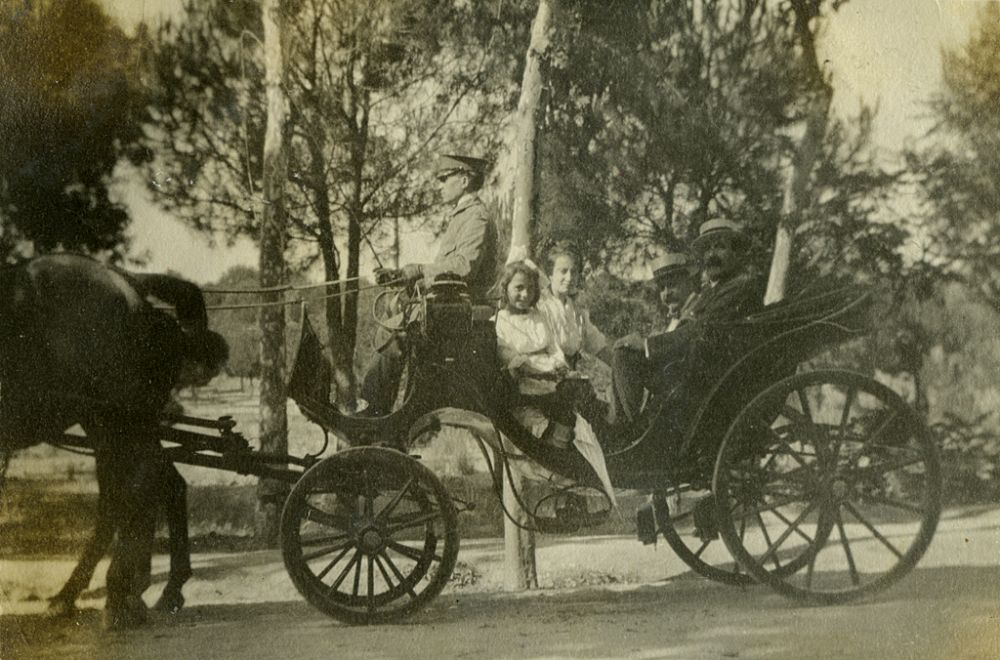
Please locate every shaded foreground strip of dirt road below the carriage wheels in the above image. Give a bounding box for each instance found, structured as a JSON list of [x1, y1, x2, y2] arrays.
[[7, 566, 1000, 658]]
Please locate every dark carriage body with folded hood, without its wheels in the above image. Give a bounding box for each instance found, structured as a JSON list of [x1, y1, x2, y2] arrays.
[[288, 281, 869, 491]]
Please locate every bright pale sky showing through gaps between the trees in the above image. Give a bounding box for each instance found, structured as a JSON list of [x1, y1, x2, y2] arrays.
[[95, 0, 984, 282]]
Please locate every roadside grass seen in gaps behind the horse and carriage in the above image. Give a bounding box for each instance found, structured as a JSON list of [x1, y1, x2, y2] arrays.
[[0, 379, 984, 556]]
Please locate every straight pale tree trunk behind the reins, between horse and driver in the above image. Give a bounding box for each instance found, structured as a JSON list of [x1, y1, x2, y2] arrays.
[[257, 0, 288, 545]]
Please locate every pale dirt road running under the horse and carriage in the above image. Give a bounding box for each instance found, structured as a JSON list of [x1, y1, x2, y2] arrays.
[[0, 510, 1000, 660]]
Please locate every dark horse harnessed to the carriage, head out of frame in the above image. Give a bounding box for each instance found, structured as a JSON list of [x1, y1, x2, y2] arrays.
[[0, 254, 224, 627]]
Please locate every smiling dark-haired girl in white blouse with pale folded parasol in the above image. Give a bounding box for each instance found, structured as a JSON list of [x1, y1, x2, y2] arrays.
[[496, 261, 615, 504]]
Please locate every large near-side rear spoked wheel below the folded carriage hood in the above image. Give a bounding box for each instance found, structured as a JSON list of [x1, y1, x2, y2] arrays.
[[713, 371, 941, 603]]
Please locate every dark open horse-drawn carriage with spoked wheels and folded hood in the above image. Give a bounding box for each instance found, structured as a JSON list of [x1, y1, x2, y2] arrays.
[[25, 270, 941, 623]]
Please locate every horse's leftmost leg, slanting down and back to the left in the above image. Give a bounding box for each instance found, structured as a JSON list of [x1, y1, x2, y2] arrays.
[[48, 451, 122, 616]]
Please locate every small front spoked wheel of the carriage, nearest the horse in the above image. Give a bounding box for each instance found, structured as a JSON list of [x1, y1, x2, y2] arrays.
[[282, 447, 458, 623]]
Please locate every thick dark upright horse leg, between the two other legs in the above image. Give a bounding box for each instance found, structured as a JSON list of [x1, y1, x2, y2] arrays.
[[105, 427, 163, 628]]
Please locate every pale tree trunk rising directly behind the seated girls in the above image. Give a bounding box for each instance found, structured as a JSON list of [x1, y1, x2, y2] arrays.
[[498, 0, 557, 591]]
